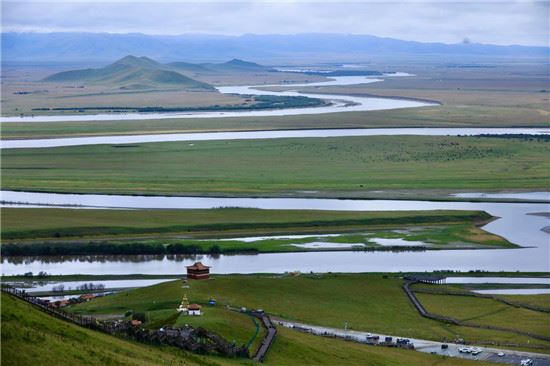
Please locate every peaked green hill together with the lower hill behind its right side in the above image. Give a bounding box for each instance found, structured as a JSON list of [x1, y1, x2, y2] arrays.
[[43, 55, 274, 90]]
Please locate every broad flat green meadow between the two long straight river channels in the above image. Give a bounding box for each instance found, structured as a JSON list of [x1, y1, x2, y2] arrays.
[[2, 136, 550, 196]]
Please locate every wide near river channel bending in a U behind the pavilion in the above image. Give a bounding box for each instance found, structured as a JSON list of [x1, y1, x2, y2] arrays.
[[1, 191, 550, 275]]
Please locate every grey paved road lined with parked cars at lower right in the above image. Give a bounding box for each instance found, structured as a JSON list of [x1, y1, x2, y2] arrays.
[[272, 317, 550, 366]]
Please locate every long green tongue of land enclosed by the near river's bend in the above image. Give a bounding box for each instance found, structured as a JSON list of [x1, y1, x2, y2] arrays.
[[1, 208, 498, 239]]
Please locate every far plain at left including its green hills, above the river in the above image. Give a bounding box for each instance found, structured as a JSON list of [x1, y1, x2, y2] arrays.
[[2, 56, 323, 117]]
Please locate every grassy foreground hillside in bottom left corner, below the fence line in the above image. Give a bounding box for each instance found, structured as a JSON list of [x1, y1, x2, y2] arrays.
[[1, 294, 225, 366]]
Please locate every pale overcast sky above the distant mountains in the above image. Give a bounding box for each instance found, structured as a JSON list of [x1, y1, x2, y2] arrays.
[[2, 0, 550, 46]]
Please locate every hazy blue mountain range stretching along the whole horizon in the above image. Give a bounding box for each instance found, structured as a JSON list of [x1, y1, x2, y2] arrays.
[[1, 33, 550, 63]]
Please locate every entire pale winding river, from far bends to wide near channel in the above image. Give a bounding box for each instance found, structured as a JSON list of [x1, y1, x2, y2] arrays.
[[1, 76, 550, 275]]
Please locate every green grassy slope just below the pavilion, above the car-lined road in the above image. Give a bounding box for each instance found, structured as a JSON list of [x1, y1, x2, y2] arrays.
[[74, 274, 550, 351]]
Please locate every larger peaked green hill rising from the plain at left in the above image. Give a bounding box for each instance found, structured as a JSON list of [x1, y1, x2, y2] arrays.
[[44, 56, 214, 90]]
